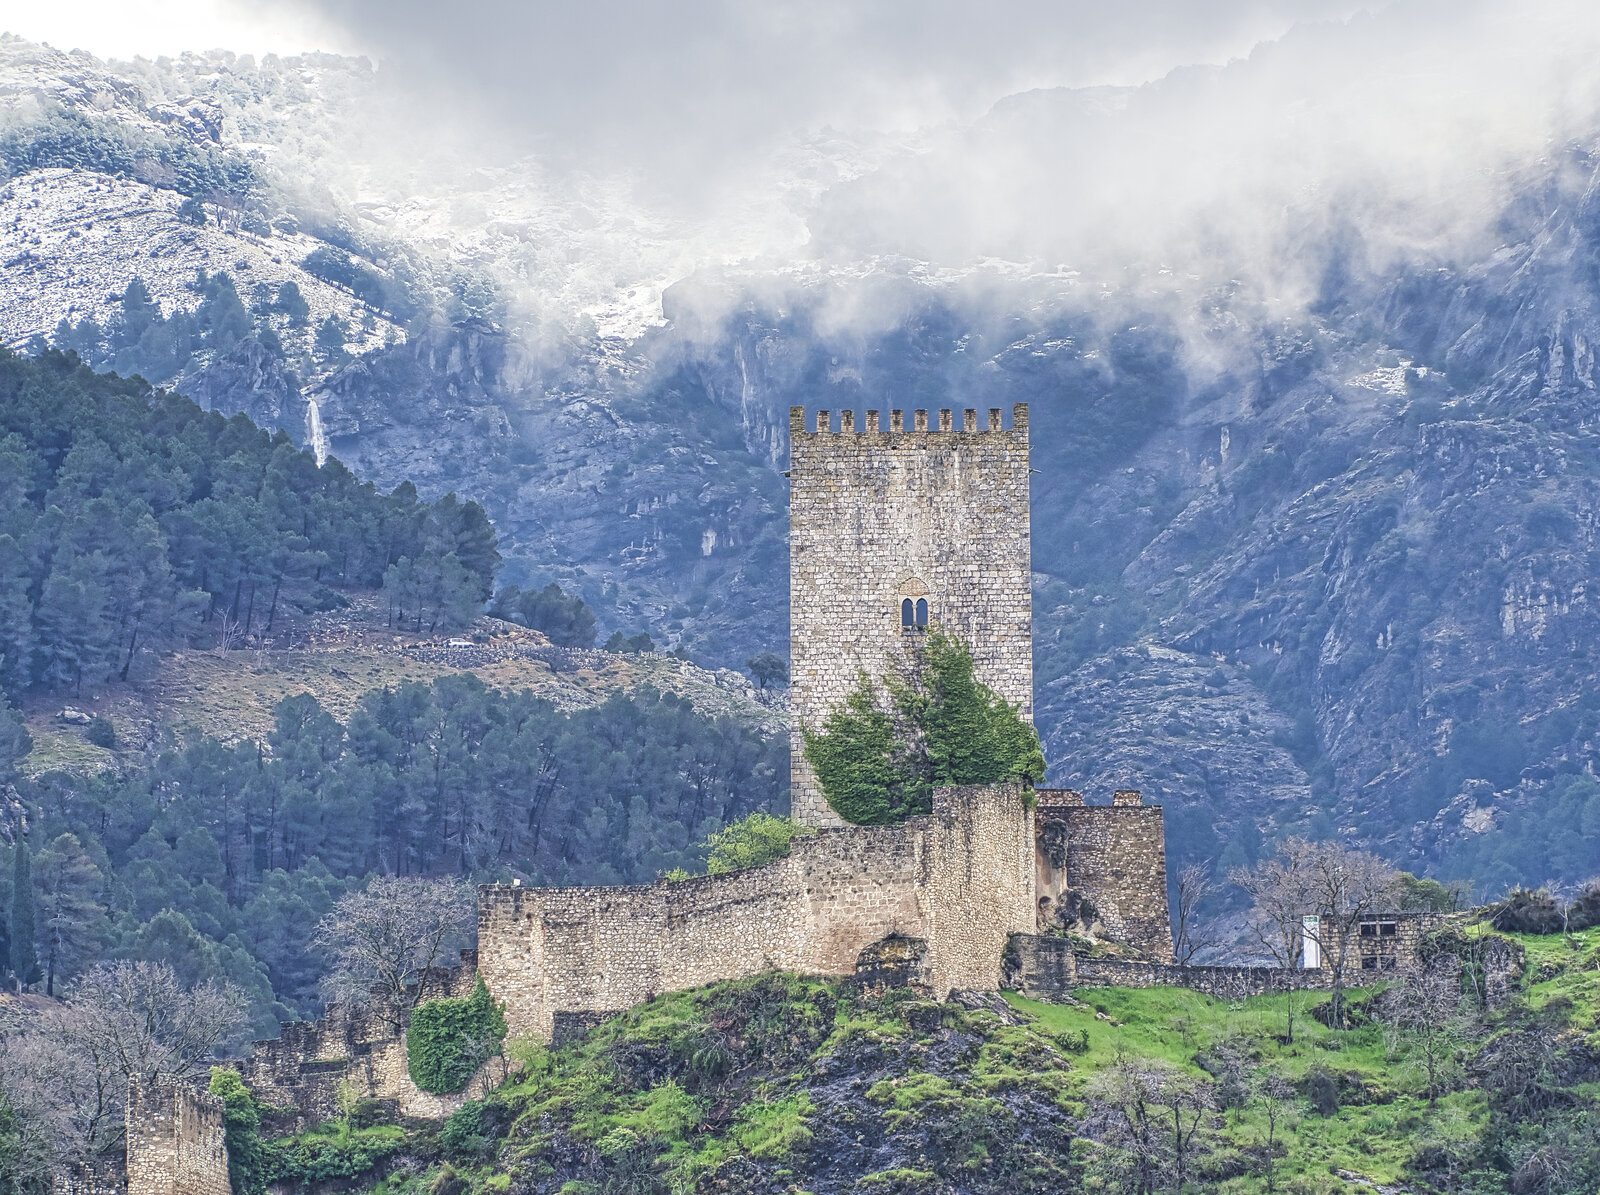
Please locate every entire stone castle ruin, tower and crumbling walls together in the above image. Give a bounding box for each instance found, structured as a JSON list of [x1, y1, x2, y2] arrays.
[[93, 403, 1184, 1195]]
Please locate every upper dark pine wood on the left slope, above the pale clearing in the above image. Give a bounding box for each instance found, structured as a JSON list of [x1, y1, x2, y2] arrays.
[[0, 349, 499, 694]]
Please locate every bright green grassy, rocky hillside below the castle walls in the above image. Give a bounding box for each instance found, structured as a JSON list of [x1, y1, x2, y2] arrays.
[[233, 931, 1600, 1195]]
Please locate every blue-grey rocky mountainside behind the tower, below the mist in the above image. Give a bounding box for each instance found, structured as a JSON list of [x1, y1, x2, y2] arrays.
[[134, 156, 1600, 883]]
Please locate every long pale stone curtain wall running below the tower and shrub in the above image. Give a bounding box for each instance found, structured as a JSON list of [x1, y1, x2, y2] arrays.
[[478, 787, 1034, 1040]]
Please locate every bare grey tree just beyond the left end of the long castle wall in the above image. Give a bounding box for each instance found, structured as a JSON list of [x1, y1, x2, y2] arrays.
[[314, 875, 474, 1008]]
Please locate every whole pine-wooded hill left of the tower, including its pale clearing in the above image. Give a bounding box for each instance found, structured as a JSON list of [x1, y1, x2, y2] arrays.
[[0, 350, 787, 1037]]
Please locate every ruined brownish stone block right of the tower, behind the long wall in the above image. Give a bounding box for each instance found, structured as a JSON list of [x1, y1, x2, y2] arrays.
[[1035, 789, 1173, 963]]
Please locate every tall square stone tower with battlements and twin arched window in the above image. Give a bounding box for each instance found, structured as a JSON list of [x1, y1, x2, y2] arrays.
[[789, 403, 1034, 825]]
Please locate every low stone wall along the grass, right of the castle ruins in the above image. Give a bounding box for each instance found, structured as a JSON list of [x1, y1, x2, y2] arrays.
[[1006, 934, 1333, 1000]]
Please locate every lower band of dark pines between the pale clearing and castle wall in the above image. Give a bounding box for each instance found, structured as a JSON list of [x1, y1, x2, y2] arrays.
[[0, 673, 787, 1035]]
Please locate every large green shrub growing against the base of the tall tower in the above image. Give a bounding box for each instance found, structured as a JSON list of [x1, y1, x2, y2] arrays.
[[802, 627, 1045, 825]]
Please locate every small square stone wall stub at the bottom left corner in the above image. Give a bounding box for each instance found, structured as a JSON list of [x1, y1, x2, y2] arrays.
[[126, 1083, 232, 1195]]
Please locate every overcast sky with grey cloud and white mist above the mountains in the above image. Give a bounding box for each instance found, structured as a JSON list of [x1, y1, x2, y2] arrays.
[[12, 0, 1600, 327]]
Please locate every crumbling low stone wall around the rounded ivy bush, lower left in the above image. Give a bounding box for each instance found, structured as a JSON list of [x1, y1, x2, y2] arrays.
[[240, 950, 498, 1131]]
